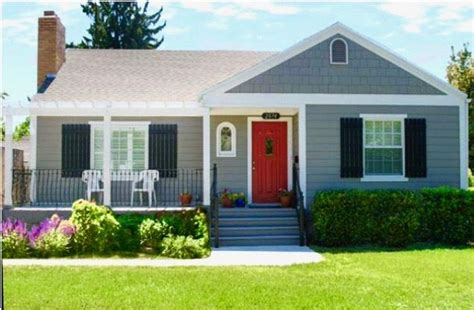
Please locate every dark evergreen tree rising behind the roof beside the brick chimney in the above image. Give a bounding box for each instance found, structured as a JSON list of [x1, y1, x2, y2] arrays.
[[67, 1, 166, 49]]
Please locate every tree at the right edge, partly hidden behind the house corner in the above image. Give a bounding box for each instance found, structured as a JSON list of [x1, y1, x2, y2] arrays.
[[446, 43, 474, 169]]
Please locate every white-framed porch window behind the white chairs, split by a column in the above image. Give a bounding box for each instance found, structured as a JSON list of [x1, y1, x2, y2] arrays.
[[91, 122, 148, 170]]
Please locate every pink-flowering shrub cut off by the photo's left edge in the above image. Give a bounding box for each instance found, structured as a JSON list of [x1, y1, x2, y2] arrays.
[[0, 218, 29, 258]]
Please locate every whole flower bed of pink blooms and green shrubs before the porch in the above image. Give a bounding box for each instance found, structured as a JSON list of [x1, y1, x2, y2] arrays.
[[0, 200, 210, 258]]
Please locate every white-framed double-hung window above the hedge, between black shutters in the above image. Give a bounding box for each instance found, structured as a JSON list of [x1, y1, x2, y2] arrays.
[[363, 115, 405, 181]]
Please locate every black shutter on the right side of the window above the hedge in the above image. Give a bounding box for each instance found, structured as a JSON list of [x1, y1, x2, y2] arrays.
[[405, 118, 427, 178]]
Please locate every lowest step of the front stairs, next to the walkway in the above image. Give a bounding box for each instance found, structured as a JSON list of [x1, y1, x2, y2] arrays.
[[213, 235, 300, 246]]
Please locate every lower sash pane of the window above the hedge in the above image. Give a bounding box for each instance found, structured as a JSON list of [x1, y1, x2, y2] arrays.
[[365, 148, 403, 175]]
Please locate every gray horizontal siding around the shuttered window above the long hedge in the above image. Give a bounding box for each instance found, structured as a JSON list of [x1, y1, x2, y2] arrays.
[[306, 105, 460, 195]]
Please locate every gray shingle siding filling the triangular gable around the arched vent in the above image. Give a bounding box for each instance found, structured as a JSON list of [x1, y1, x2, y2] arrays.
[[228, 35, 444, 95]]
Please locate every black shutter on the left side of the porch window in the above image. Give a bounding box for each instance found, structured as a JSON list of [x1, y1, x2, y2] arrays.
[[61, 124, 91, 178]]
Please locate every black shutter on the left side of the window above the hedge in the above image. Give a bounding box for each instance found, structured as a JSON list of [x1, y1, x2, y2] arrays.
[[341, 118, 363, 178]]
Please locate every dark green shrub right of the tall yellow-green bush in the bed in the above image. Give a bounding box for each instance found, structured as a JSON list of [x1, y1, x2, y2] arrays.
[[117, 214, 149, 252]]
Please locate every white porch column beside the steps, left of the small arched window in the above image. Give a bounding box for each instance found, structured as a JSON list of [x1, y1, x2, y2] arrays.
[[202, 109, 211, 206]]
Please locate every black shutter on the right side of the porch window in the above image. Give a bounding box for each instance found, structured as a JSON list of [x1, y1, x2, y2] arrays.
[[148, 124, 178, 178]]
